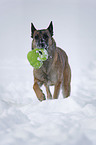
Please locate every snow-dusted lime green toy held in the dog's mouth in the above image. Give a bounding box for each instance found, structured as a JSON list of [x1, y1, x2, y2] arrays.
[[27, 48, 48, 69]]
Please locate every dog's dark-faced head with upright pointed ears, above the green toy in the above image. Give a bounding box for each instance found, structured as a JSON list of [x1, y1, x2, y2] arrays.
[[31, 21, 53, 49]]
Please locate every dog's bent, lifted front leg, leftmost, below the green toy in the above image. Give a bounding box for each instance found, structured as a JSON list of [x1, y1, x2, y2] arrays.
[[33, 79, 46, 101]]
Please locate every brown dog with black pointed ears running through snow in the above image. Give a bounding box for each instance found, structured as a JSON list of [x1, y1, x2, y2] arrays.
[[31, 21, 71, 101]]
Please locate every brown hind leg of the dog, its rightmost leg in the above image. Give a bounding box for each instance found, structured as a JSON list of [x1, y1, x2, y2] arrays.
[[62, 63, 71, 98]]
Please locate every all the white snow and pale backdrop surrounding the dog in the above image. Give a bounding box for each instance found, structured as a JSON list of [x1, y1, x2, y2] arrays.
[[0, 0, 96, 145]]
